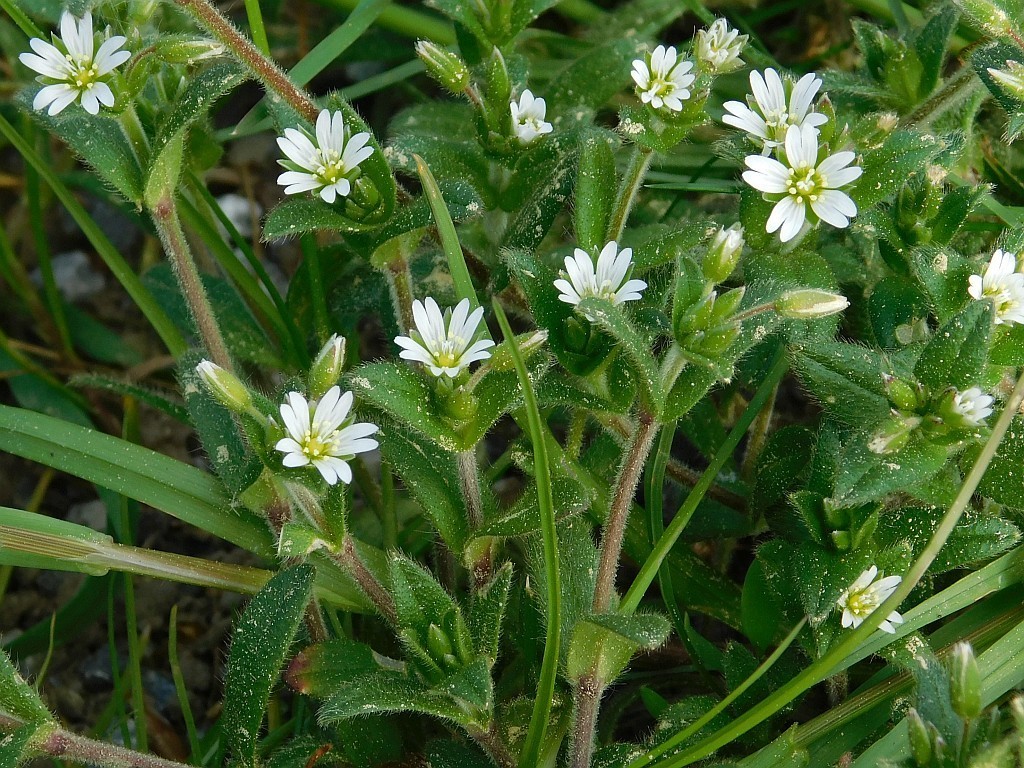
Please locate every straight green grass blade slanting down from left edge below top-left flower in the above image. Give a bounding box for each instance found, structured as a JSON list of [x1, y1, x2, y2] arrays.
[[0, 115, 188, 356]]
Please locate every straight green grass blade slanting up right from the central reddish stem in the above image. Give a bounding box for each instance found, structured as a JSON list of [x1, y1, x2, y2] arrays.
[[618, 349, 787, 614]]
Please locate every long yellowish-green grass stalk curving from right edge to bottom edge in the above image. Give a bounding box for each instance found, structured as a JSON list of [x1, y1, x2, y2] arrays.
[[643, 360, 1024, 768]]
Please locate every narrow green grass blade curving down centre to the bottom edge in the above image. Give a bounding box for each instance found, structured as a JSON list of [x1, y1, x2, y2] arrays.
[[493, 301, 562, 768]]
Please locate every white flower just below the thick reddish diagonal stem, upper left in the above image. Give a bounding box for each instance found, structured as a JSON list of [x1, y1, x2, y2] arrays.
[[278, 110, 374, 203]]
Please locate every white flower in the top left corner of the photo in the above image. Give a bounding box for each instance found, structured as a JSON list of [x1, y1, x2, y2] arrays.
[[18, 10, 131, 115]]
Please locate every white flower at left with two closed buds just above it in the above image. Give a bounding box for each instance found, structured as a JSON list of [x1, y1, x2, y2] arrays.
[[274, 387, 377, 485]]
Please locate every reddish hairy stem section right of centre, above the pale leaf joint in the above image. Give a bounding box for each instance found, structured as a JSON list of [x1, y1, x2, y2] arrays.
[[594, 413, 657, 613]]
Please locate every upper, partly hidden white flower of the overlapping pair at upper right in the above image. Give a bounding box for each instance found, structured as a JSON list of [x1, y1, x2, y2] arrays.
[[722, 69, 828, 155]]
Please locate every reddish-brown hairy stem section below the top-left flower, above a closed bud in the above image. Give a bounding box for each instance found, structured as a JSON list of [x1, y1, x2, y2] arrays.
[[151, 195, 234, 371]]
